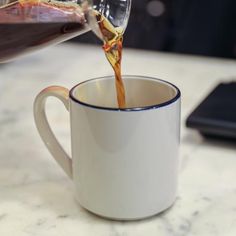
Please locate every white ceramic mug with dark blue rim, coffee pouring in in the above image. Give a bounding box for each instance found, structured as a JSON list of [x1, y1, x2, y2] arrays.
[[34, 76, 180, 220]]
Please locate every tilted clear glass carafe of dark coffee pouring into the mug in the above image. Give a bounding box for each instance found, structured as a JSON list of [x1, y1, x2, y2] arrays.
[[0, 0, 131, 63]]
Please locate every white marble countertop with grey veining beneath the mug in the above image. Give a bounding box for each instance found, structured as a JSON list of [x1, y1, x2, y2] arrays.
[[0, 44, 236, 236]]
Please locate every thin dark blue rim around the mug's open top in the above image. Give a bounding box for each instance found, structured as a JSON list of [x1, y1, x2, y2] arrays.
[[70, 75, 181, 112]]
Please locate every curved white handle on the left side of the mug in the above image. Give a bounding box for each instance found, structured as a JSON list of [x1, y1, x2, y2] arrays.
[[34, 86, 72, 179]]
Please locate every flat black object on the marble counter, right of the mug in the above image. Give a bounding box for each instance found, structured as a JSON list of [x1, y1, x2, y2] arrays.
[[186, 82, 236, 139]]
